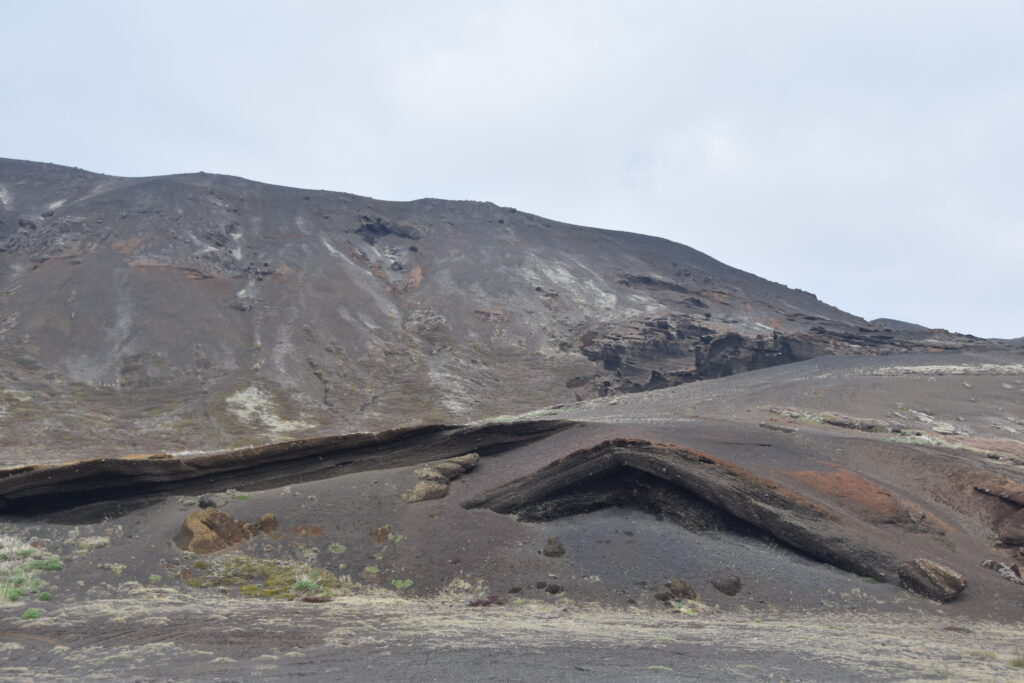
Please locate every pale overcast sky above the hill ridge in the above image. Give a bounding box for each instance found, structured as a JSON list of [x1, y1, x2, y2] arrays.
[[0, 0, 1024, 337]]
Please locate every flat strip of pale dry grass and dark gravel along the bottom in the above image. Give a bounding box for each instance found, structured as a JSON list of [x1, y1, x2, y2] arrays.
[[0, 587, 1024, 681]]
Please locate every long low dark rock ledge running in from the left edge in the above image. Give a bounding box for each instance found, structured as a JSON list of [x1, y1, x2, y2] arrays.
[[0, 420, 574, 514]]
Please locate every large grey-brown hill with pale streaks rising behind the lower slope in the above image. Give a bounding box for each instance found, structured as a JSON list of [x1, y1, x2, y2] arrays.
[[0, 156, 995, 465]]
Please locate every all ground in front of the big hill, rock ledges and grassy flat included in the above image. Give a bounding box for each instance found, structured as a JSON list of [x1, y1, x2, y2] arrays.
[[0, 353, 1024, 681]]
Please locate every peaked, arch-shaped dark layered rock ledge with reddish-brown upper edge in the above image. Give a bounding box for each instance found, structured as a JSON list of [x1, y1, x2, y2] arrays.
[[464, 439, 966, 600]]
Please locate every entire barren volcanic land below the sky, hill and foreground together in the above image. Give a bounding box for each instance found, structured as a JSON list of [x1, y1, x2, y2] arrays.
[[0, 161, 1024, 681]]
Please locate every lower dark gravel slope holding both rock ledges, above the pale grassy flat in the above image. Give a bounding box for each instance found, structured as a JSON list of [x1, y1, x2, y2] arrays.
[[0, 353, 1024, 628]]
